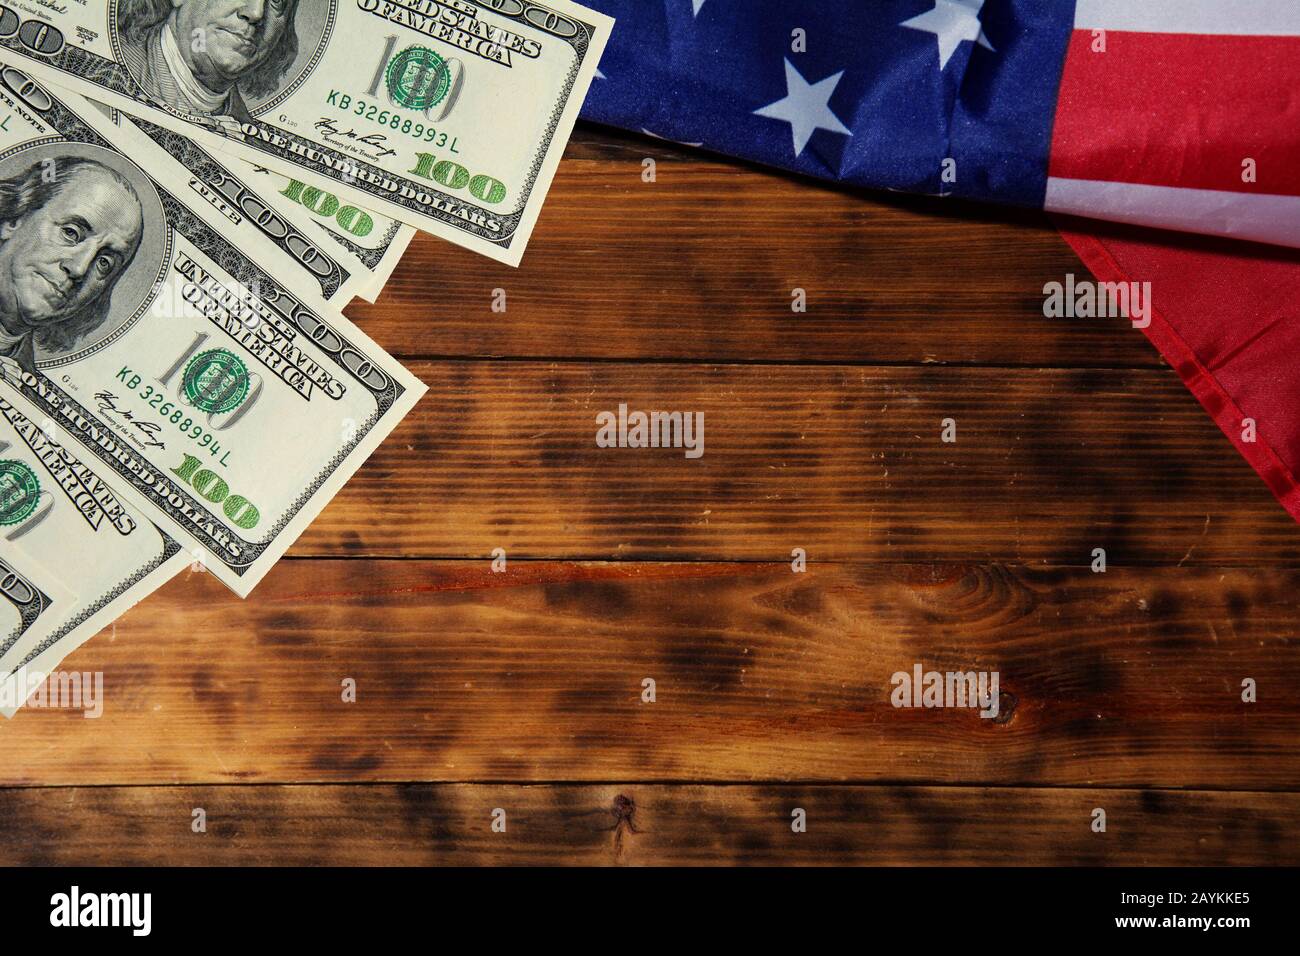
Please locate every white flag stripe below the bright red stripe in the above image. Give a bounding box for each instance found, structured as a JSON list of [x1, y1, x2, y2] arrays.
[[1044, 177, 1300, 247]]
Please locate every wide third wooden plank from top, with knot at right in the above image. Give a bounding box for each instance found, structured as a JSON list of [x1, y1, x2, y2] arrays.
[[0, 561, 1300, 790]]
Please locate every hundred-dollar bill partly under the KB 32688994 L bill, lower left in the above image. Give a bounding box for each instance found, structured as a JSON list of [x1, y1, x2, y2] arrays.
[[0, 384, 190, 717]]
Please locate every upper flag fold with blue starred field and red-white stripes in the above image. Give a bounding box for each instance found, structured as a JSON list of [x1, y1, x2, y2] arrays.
[[582, 0, 1300, 246]]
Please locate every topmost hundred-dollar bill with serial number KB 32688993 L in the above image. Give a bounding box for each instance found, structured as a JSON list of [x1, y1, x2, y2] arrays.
[[0, 0, 614, 265]]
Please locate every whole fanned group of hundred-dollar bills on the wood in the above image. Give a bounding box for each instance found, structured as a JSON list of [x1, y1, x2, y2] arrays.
[[0, 0, 612, 717]]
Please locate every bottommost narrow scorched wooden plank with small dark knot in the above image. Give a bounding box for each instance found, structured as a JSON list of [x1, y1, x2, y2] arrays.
[[0, 783, 1300, 866]]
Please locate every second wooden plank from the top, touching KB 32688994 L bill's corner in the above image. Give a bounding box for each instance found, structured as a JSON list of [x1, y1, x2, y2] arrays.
[[294, 362, 1300, 566]]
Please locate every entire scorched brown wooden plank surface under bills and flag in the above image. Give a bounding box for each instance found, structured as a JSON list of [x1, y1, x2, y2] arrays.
[[0, 127, 1300, 864]]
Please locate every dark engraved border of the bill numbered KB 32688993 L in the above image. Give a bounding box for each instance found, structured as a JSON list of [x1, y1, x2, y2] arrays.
[[0, 0, 595, 250]]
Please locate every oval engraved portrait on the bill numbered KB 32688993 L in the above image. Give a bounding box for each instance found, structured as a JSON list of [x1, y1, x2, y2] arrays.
[[117, 0, 298, 122]]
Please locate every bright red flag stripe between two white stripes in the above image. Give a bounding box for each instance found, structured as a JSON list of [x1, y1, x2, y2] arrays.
[[1049, 30, 1300, 196]]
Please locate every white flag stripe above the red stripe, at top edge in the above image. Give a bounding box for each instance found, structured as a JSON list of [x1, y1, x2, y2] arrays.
[[1074, 0, 1300, 36]]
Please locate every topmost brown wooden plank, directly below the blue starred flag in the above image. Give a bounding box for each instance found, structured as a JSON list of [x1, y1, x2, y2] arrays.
[[347, 125, 1161, 367]]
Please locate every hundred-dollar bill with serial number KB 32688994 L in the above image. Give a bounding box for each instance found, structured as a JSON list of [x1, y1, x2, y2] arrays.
[[0, 66, 425, 596]]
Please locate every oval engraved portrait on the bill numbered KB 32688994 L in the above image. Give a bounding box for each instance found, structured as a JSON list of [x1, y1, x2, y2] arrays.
[[0, 157, 144, 372]]
